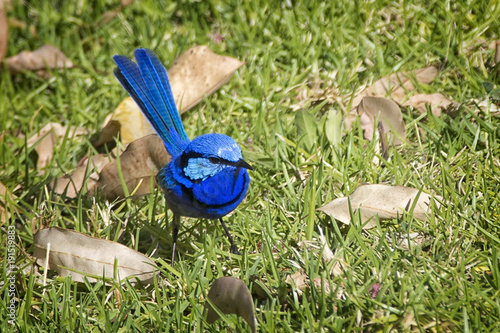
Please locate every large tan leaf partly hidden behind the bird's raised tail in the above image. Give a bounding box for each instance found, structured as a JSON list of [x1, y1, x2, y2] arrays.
[[96, 45, 244, 145]]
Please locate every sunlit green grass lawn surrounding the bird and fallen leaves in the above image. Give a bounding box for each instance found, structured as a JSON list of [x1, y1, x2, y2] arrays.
[[0, 0, 500, 332]]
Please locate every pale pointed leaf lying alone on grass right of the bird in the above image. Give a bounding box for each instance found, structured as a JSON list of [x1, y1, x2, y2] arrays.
[[318, 184, 442, 229]]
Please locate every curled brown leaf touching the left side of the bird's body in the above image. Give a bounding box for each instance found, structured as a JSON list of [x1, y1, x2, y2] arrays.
[[89, 134, 170, 201]]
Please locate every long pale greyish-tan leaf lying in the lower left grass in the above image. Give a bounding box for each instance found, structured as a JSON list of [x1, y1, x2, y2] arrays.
[[33, 227, 157, 284]]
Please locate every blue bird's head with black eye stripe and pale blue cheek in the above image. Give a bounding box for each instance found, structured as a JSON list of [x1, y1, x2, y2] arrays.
[[180, 134, 253, 181]]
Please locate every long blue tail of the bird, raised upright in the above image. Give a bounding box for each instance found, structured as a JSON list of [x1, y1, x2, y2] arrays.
[[113, 49, 189, 156]]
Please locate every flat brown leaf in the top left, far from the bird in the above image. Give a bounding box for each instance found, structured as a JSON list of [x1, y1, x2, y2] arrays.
[[5, 44, 74, 73]]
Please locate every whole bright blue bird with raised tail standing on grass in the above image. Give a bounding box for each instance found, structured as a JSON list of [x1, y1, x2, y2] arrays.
[[113, 49, 253, 265]]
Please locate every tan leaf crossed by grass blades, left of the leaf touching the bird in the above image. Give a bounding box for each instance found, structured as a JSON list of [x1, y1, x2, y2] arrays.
[[49, 154, 111, 198]]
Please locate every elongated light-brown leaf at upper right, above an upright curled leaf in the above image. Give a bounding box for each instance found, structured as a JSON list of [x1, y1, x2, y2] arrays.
[[352, 66, 438, 108]]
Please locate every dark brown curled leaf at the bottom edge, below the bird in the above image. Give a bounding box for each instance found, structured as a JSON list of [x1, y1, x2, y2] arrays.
[[205, 277, 257, 332]]
